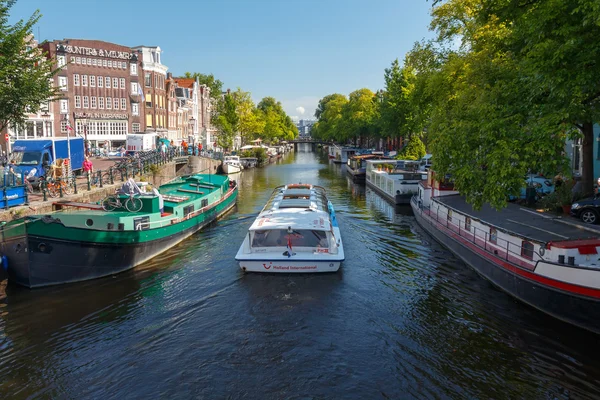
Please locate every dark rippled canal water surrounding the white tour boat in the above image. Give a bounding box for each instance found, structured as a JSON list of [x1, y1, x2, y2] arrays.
[[0, 148, 600, 399]]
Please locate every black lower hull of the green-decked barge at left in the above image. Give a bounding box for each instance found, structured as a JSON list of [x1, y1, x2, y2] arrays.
[[3, 202, 235, 288]]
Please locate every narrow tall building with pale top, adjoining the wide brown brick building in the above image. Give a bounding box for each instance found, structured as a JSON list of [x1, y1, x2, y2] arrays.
[[133, 46, 168, 140]]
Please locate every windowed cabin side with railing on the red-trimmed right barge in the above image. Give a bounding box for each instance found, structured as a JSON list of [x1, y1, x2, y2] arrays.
[[411, 196, 542, 267]]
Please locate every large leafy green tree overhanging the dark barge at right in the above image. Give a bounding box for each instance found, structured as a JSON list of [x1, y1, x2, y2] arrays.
[[410, 0, 600, 207]]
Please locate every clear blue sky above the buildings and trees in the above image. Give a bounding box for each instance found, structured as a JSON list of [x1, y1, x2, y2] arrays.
[[10, 0, 432, 118]]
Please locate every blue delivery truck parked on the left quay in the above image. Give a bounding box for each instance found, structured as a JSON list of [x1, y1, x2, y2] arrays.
[[9, 137, 85, 183]]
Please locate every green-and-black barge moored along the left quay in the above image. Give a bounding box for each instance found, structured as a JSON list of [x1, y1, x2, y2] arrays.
[[0, 174, 238, 288]]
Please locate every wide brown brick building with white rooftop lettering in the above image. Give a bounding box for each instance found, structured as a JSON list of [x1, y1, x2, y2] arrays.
[[41, 39, 145, 149]]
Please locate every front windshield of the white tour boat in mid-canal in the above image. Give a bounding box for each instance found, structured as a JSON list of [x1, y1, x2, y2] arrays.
[[252, 229, 329, 248]]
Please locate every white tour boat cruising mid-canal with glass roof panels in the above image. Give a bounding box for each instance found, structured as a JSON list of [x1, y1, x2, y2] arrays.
[[235, 184, 344, 273]]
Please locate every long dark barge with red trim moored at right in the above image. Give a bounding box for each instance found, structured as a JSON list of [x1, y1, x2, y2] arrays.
[[411, 172, 600, 333]]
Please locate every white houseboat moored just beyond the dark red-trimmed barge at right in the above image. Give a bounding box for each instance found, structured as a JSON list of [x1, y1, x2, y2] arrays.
[[366, 160, 427, 205]]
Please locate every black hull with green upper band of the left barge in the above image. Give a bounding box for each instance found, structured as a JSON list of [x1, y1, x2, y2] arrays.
[[2, 188, 237, 288]]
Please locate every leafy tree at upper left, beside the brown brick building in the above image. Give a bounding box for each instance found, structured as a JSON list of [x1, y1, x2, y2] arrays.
[[0, 0, 58, 131]]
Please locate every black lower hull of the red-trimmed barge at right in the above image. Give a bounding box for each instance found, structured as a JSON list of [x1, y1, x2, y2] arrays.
[[411, 203, 600, 333]]
